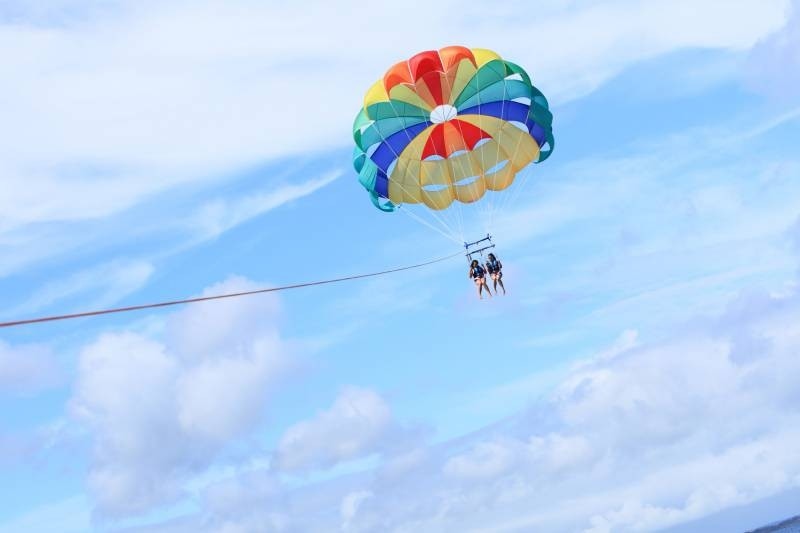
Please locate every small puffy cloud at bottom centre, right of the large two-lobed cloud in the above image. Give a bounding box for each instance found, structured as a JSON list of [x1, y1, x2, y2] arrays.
[[273, 387, 392, 472]]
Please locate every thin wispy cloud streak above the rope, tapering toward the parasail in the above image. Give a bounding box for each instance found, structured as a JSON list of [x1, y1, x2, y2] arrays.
[[0, 164, 340, 316]]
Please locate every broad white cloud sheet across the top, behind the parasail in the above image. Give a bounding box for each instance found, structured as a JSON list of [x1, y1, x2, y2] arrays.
[[0, 0, 787, 235]]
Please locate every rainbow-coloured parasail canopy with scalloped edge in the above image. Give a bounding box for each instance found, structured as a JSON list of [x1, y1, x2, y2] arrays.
[[353, 46, 554, 211]]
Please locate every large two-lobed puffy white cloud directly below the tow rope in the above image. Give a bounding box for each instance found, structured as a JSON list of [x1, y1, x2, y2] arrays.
[[71, 278, 289, 515]]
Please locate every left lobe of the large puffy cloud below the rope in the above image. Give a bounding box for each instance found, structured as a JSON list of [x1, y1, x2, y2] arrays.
[[72, 334, 186, 514]]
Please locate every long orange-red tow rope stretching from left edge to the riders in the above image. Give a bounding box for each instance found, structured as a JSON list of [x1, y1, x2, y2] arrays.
[[0, 251, 463, 328]]
